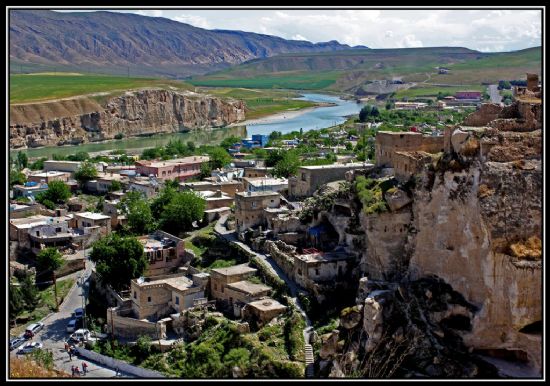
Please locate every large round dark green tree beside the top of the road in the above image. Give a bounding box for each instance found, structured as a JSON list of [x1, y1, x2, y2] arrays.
[[90, 234, 148, 291]]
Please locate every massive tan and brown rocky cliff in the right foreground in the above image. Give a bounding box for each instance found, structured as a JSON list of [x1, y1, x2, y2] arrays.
[[314, 102, 542, 377]]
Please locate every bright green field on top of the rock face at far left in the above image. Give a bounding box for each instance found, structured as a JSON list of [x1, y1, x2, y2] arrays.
[[10, 73, 192, 103]]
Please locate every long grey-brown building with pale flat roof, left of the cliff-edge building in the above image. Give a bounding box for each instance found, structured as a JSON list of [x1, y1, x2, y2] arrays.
[[288, 163, 372, 198]]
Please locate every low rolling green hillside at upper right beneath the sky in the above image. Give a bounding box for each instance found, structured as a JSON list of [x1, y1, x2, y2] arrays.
[[190, 47, 542, 91]]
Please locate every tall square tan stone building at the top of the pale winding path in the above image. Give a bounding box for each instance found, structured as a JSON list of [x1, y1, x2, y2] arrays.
[[235, 192, 281, 233]]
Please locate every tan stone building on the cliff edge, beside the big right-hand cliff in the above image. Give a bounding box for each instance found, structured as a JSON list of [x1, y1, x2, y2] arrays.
[[375, 131, 444, 167]]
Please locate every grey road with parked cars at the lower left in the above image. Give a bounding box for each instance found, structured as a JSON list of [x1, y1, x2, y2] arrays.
[[10, 252, 131, 378]]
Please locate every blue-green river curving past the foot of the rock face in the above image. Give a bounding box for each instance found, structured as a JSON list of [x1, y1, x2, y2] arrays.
[[10, 93, 362, 158]]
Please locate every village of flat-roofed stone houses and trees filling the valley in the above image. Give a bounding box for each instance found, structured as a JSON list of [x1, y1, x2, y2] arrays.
[[9, 76, 541, 377]]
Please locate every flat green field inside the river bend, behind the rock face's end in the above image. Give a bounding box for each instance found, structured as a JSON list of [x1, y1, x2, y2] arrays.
[[197, 88, 315, 119]]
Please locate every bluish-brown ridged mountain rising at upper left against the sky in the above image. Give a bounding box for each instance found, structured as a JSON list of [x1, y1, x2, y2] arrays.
[[9, 10, 362, 77]]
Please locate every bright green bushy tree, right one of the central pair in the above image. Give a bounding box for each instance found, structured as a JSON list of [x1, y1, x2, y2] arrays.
[[161, 191, 206, 234]]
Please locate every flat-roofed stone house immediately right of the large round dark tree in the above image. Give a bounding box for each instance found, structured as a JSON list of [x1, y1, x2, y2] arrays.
[[139, 230, 186, 276]]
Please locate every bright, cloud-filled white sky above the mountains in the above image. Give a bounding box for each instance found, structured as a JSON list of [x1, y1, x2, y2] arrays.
[[57, 9, 542, 52]]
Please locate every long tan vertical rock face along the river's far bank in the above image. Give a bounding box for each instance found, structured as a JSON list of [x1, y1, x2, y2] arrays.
[[10, 90, 246, 148]]
